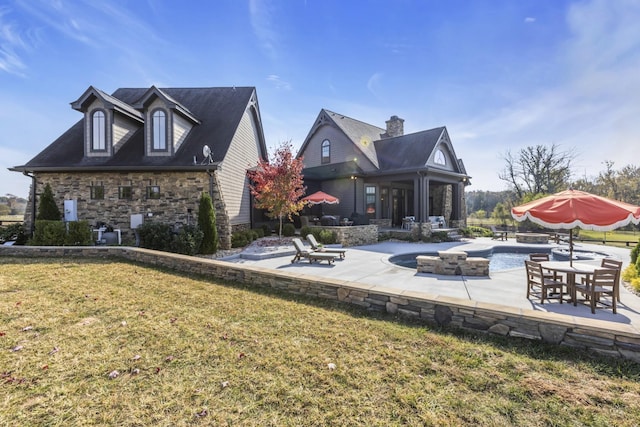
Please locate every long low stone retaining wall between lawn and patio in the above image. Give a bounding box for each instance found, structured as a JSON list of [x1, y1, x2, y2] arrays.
[[0, 246, 640, 363]]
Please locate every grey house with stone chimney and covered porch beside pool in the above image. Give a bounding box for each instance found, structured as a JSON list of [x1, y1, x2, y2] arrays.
[[297, 109, 470, 231]]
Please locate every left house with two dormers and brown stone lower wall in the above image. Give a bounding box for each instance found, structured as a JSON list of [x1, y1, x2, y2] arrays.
[[11, 86, 267, 248]]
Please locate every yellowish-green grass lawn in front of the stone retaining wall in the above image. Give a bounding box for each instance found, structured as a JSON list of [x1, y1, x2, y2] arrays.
[[0, 258, 640, 426]]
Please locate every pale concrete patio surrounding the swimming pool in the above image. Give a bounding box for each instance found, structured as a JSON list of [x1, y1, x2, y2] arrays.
[[221, 238, 640, 332]]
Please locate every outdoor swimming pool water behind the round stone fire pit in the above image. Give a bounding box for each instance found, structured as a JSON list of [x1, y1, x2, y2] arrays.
[[389, 247, 608, 272]]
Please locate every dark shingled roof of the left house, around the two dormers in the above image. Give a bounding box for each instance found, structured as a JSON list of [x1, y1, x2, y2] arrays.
[[12, 87, 266, 171]]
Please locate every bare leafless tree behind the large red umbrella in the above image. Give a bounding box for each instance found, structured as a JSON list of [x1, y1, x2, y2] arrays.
[[498, 144, 575, 199]]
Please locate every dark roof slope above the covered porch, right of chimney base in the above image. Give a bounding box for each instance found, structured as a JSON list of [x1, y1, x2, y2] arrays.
[[375, 127, 445, 170]]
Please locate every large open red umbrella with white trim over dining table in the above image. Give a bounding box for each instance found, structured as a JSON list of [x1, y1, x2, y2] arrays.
[[511, 189, 640, 264]]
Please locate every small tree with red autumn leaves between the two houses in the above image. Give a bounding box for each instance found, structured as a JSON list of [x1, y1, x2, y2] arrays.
[[248, 143, 306, 237]]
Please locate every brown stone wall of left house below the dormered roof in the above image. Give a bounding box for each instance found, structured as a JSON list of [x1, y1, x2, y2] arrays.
[[25, 171, 232, 249]]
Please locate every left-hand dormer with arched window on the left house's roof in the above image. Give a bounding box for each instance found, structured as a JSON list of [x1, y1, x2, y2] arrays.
[[71, 86, 143, 157]]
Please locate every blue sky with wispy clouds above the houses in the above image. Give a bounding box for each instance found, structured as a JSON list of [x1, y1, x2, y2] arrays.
[[0, 0, 640, 197]]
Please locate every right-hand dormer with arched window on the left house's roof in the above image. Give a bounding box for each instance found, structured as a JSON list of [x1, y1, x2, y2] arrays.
[[134, 86, 200, 156]]
